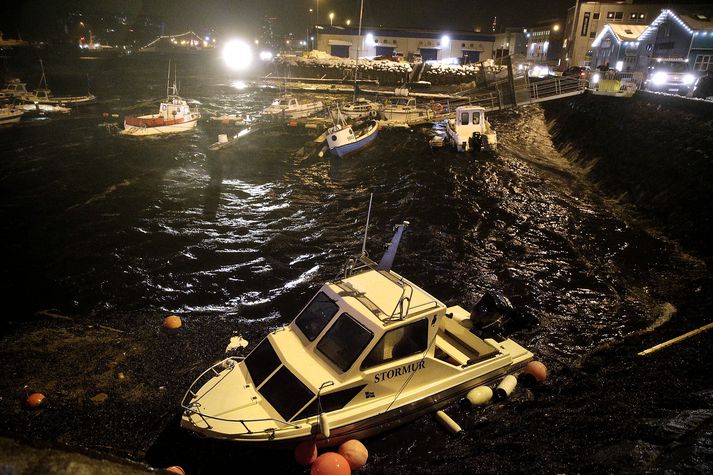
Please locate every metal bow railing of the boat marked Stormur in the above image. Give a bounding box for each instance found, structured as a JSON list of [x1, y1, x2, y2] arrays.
[[181, 356, 300, 437]]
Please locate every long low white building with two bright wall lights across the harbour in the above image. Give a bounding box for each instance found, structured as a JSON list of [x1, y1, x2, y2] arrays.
[[313, 25, 495, 63]]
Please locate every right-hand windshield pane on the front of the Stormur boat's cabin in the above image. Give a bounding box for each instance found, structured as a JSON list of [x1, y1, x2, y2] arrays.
[[317, 313, 374, 371]]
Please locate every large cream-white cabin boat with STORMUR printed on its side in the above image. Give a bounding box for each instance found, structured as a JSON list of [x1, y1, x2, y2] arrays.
[[181, 207, 533, 447]]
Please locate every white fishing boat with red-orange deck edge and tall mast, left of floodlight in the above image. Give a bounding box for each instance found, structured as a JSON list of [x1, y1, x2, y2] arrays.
[[121, 62, 201, 137]]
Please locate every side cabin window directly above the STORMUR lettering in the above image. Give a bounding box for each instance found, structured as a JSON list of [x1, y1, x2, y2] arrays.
[[361, 319, 428, 370]]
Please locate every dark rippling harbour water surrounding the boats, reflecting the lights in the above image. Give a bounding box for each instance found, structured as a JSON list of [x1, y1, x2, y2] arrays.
[[0, 54, 713, 473]]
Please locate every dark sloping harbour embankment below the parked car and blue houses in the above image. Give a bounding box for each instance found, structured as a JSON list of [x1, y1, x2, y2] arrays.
[[542, 92, 713, 263]]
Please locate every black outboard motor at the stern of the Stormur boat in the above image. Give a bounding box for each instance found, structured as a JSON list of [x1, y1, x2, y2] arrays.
[[470, 291, 537, 340]]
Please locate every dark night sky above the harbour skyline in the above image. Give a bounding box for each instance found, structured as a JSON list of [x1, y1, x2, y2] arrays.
[[0, 0, 710, 39]]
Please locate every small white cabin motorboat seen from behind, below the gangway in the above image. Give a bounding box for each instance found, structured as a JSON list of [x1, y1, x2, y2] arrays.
[[446, 106, 498, 152]]
